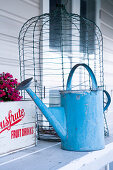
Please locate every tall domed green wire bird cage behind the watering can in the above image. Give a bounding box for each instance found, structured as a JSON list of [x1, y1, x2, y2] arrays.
[[19, 5, 108, 138]]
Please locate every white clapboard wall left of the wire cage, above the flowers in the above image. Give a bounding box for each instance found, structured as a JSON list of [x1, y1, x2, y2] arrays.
[[0, 0, 40, 81]]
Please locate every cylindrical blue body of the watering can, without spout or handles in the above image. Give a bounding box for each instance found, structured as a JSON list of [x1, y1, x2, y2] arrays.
[[61, 90, 105, 151]]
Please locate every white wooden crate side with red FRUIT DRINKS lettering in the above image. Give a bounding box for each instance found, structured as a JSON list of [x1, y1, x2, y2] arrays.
[[0, 101, 36, 154]]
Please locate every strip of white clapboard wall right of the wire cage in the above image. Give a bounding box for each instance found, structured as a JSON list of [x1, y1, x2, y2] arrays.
[[100, 0, 113, 133]]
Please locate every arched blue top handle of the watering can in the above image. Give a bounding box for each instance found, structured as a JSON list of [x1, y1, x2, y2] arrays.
[[66, 63, 98, 90]]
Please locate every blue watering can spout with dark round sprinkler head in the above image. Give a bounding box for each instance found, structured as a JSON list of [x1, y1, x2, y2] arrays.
[[16, 78, 66, 141]]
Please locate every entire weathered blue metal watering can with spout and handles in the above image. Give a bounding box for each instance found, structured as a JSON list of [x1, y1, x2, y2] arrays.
[[17, 64, 111, 151]]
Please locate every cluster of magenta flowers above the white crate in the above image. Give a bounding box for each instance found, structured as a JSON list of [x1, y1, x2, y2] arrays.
[[0, 72, 22, 102]]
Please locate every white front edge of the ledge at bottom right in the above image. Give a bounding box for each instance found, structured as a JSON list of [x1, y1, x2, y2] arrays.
[[60, 143, 113, 170]]
